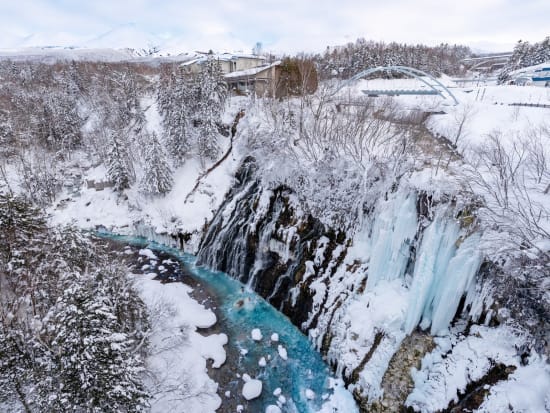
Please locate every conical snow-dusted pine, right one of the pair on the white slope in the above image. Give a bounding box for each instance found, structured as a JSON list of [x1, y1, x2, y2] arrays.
[[140, 133, 174, 195]]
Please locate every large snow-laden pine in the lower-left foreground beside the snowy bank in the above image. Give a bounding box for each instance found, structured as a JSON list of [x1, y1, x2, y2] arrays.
[[36, 274, 146, 413]]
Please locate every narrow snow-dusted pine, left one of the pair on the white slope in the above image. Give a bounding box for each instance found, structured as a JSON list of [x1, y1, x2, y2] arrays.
[[107, 133, 134, 191]]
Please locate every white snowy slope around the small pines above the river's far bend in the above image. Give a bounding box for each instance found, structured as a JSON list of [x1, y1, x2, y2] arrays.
[[49, 102, 240, 253]]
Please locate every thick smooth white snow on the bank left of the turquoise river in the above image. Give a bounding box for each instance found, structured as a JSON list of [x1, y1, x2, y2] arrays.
[[134, 273, 227, 413]]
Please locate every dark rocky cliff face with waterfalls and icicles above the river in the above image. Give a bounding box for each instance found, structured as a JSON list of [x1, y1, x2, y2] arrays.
[[198, 158, 532, 411]]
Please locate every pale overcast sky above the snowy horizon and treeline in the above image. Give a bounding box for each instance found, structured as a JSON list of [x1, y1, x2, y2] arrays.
[[0, 0, 550, 52]]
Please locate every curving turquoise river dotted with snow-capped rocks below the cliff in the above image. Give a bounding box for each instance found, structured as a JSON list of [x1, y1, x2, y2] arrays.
[[96, 232, 357, 413]]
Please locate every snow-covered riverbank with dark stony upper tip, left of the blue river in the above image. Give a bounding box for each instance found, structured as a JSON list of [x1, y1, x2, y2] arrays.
[[106, 239, 227, 413]]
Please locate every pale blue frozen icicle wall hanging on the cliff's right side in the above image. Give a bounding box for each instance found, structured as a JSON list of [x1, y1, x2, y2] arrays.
[[362, 190, 482, 334]]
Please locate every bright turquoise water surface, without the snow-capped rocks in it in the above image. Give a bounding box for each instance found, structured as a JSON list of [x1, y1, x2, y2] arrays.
[[97, 232, 351, 413]]
